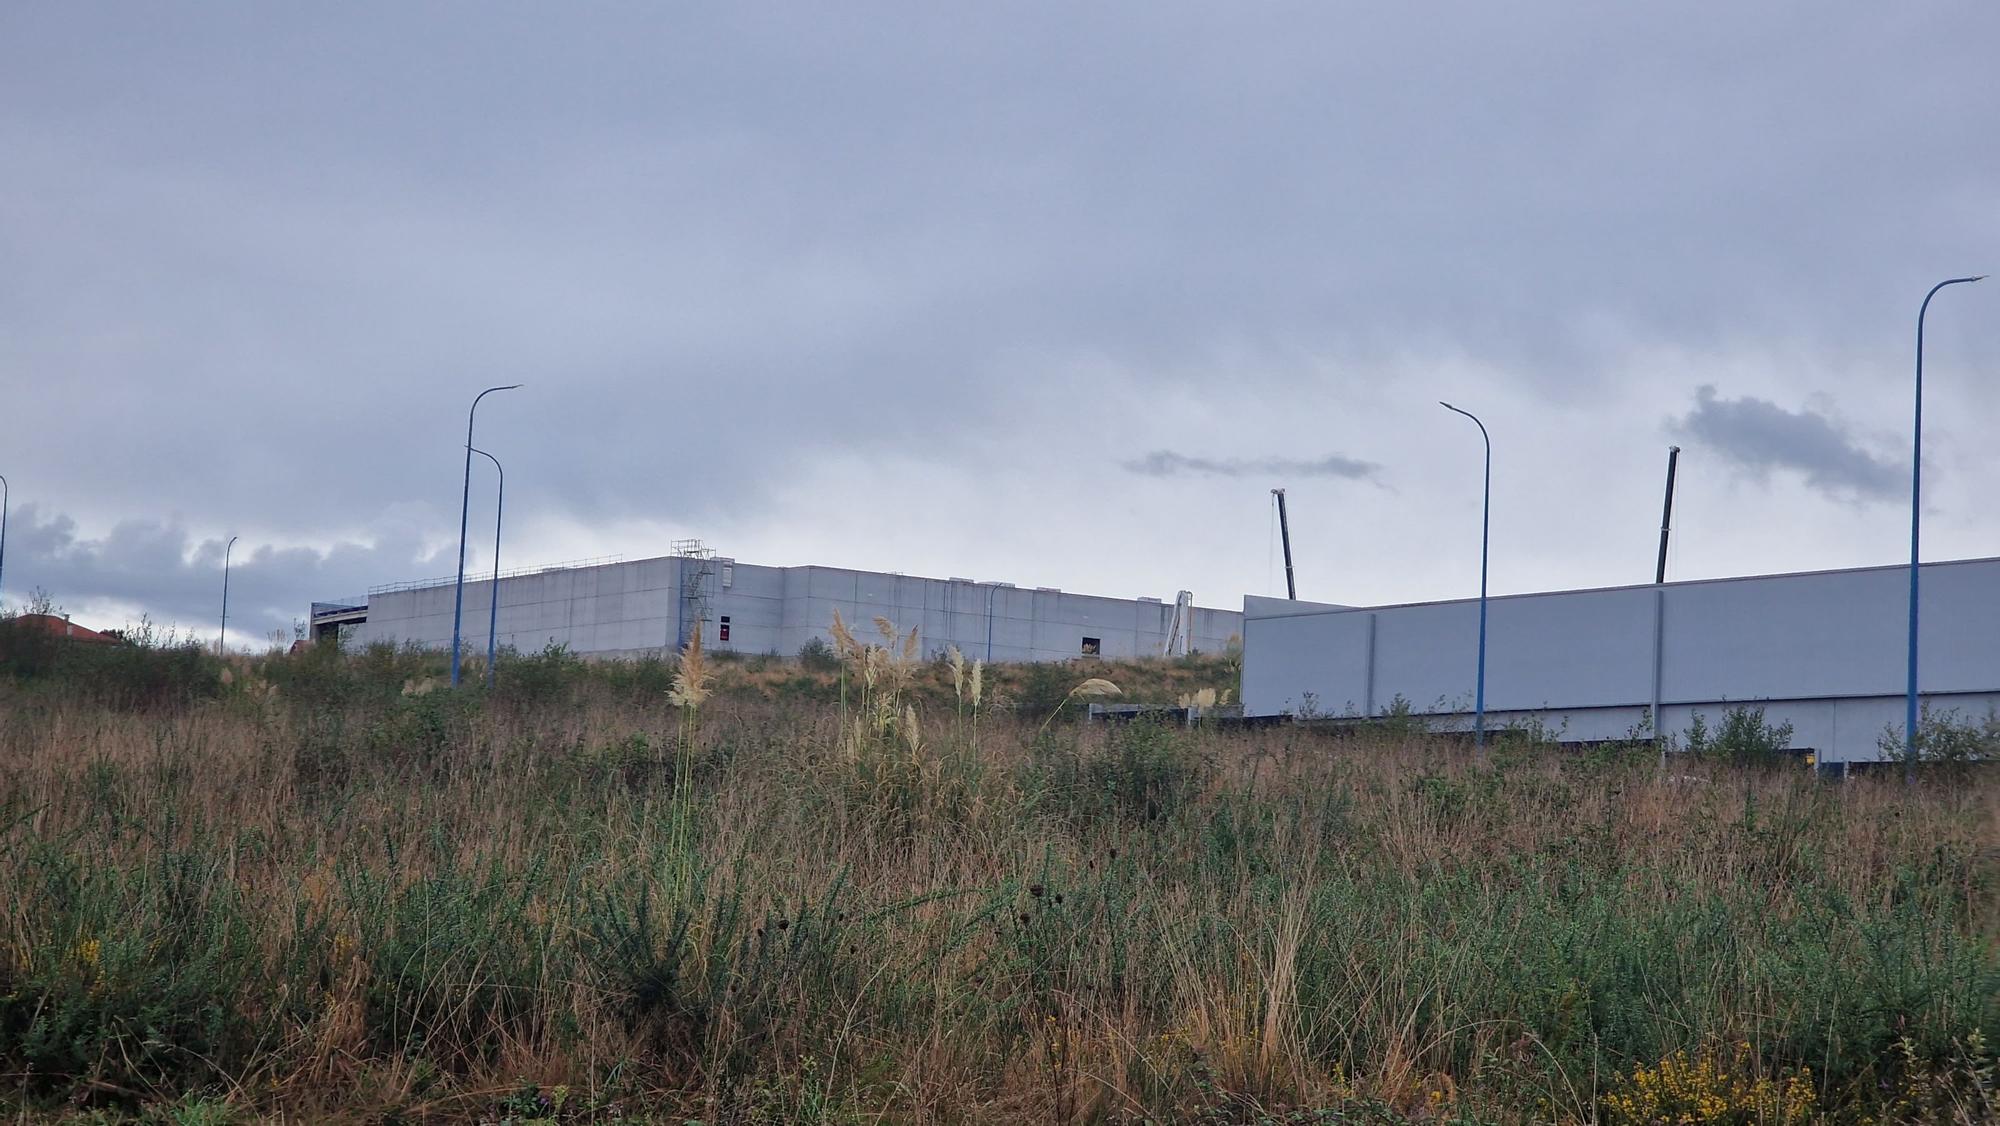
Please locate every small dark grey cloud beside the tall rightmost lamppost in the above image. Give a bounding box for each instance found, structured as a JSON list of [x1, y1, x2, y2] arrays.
[[1672, 386, 1910, 500]]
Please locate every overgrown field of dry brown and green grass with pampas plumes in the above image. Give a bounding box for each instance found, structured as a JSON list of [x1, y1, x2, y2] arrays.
[[0, 638, 2000, 1124]]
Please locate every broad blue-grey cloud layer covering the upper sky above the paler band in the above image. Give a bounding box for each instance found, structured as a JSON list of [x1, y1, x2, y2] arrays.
[[0, 0, 2000, 620]]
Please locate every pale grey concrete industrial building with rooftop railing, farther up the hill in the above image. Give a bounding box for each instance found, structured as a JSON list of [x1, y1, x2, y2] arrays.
[[312, 542, 1242, 660]]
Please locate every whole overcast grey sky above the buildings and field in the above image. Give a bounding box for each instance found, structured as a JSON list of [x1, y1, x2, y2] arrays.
[[0, 0, 2000, 638]]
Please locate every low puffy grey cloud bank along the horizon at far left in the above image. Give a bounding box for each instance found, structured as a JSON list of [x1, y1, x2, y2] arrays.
[[4, 504, 454, 644]]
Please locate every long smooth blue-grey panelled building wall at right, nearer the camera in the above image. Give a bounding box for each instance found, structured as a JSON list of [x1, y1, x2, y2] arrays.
[[1244, 560, 2000, 762]]
